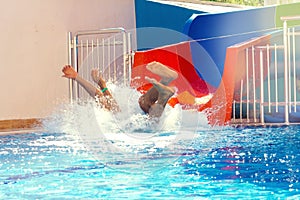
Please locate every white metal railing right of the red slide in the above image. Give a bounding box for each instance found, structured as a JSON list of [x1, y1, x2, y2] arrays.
[[232, 16, 300, 125]]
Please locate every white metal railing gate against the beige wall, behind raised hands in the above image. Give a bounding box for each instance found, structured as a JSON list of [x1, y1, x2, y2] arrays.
[[68, 28, 132, 101]]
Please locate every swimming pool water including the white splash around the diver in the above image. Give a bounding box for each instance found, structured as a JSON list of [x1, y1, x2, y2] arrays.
[[0, 98, 300, 199]]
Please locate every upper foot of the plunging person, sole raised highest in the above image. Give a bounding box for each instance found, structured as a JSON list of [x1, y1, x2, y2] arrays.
[[146, 61, 178, 85]]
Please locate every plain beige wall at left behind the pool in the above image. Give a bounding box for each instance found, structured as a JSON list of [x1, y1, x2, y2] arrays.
[[0, 0, 135, 120]]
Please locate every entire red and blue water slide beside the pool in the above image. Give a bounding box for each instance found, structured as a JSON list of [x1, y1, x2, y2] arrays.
[[132, 3, 300, 125]]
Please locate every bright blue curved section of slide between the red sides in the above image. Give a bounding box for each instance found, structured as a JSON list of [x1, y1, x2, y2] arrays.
[[184, 7, 276, 87]]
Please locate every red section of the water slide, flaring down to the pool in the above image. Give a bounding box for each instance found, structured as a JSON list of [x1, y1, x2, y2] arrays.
[[132, 35, 270, 125]]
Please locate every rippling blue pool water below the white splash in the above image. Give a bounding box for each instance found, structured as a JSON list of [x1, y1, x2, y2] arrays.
[[0, 126, 300, 199]]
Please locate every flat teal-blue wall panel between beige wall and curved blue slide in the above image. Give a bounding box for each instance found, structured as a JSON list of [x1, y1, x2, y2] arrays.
[[135, 0, 205, 50]]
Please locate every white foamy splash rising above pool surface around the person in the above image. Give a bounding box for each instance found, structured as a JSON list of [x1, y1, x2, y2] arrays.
[[43, 83, 209, 134]]
